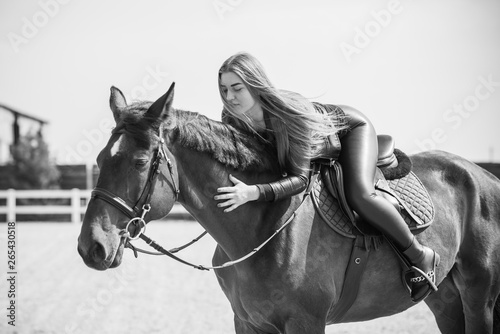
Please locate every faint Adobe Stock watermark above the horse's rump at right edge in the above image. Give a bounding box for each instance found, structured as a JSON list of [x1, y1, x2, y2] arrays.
[[413, 74, 500, 153]]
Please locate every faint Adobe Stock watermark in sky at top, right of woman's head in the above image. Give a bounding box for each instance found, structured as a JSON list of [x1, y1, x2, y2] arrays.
[[339, 0, 403, 63]]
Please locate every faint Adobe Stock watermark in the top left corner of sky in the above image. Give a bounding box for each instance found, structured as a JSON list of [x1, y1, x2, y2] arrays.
[[7, 0, 71, 53]]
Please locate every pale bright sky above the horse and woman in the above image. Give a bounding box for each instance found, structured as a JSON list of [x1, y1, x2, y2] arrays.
[[0, 0, 500, 164]]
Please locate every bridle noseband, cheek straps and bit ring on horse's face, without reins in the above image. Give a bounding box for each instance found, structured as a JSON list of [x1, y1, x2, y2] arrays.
[[91, 126, 180, 244]]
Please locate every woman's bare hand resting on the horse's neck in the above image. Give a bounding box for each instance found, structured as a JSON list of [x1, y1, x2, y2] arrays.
[[214, 174, 259, 212]]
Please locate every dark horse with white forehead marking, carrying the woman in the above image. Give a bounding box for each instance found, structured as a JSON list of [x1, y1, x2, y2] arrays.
[[77, 84, 500, 334]]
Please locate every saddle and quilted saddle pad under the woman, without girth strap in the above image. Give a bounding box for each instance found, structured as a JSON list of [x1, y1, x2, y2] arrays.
[[311, 135, 434, 239]]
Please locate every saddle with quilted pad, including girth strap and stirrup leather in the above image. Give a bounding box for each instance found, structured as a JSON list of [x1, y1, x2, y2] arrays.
[[310, 135, 434, 323]]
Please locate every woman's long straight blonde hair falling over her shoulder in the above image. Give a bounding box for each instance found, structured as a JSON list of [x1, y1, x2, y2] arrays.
[[219, 52, 338, 175]]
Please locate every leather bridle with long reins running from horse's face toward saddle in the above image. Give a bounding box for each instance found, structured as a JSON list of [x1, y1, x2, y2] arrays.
[[91, 126, 319, 271]]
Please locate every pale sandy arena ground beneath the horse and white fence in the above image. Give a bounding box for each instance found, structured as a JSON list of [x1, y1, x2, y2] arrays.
[[0, 222, 439, 334]]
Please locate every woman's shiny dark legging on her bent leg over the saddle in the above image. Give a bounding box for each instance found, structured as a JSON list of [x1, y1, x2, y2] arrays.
[[339, 107, 413, 250]]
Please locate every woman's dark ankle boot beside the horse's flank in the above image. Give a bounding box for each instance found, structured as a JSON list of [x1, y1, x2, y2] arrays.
[[403, 237, 439, 302]]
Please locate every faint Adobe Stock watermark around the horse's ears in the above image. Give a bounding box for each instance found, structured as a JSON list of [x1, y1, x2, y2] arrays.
[[58, 65, 169, 164]]
